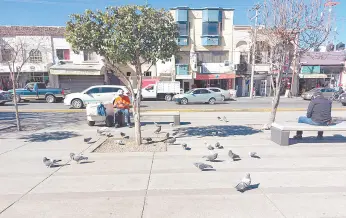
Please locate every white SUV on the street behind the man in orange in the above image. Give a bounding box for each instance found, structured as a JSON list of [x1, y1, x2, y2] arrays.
[[64, 85, 130, 109]]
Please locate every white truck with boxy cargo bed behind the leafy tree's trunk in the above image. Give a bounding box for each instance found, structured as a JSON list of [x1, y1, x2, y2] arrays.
[[134, 81, 181, 101]]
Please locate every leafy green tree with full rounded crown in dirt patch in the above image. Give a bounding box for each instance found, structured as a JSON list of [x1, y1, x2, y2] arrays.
[[66, 5, 179, 145]]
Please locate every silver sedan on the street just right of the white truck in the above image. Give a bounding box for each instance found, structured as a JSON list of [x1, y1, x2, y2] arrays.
[[174, 88, 222, 104]]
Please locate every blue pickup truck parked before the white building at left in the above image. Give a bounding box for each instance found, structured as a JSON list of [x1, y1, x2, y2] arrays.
[[9, 82, 65, 103]]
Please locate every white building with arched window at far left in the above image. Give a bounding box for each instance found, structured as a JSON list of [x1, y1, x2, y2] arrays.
[[0, 26, 65, 89]]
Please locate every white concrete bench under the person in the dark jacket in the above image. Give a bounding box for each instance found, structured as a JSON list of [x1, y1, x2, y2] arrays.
[[271, 122, 346, 145]]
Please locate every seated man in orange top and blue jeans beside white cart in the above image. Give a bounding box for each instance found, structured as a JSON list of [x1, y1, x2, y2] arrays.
[[114, 89, 131, 127]]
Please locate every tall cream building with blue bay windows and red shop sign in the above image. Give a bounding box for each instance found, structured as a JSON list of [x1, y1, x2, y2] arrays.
[[157, 7, 235, 90]]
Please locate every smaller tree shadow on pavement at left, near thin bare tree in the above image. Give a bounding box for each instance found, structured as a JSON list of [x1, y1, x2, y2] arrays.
[[20, 131, 81, 142]]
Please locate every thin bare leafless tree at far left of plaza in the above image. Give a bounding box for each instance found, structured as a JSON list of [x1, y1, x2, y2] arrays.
[[0, 36, 46, 131]]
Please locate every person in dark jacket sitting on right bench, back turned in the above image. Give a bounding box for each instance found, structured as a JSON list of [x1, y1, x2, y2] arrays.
[[294, 92, 332, 139]]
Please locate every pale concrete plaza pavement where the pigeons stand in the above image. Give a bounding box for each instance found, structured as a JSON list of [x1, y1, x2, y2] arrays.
[[0, 112, 346, 218]]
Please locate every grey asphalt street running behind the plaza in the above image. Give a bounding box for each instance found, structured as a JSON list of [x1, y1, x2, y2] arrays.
[[0, 98, 346, 112]]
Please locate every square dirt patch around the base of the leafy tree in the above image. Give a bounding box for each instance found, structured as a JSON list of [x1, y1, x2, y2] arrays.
[[93, 137, 167, 153]]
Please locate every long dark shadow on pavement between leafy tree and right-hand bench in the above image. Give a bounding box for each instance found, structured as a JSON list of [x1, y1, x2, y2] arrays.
[[173, 125, 262, 137]]
